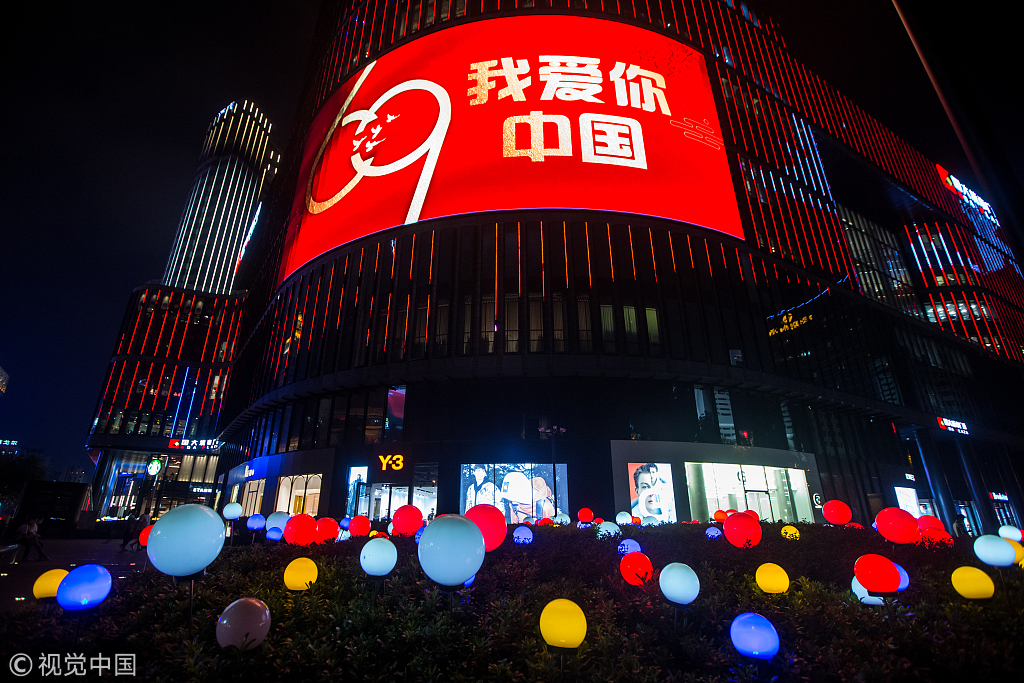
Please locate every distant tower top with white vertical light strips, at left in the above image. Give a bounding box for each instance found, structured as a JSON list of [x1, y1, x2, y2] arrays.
[[163, 101, 281, 294]]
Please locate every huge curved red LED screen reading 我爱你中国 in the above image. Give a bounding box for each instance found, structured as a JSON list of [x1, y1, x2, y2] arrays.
[[282, 15, 742, 278]]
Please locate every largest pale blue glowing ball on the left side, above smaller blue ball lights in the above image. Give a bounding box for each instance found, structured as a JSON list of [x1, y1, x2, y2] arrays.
[[146, 504, 224, 577]]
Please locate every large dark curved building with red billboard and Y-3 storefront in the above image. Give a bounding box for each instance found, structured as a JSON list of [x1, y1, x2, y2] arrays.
[[211, 0, 1024, 531]]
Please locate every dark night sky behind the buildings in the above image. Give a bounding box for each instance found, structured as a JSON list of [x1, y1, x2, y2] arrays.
[[0, 0, 1024, 476]]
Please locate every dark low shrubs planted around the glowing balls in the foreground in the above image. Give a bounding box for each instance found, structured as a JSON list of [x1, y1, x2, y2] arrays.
[[0, 524, 1024, 683]]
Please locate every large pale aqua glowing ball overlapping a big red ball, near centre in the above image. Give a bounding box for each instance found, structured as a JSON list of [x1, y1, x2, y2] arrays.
[[417, 515, 486, 587]]
